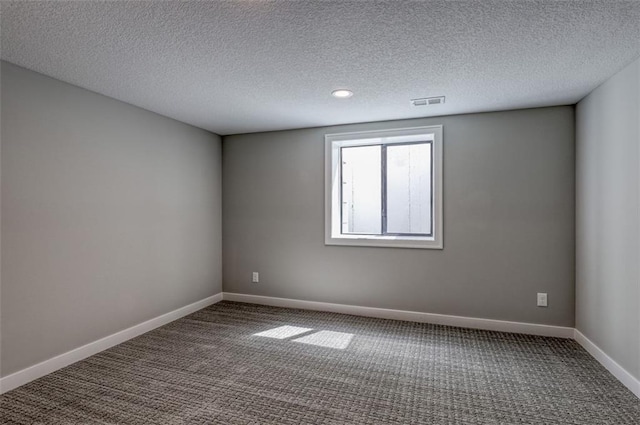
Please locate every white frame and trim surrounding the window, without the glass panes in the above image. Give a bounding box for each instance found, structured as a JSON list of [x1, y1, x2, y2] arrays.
[[324, 125, 444, 249]]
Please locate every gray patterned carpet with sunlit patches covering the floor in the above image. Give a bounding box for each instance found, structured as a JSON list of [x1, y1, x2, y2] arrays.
[[0, 301, 640, 425]]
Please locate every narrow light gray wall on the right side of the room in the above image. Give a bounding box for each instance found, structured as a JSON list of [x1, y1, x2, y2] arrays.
[[576, 56, 640, 379]]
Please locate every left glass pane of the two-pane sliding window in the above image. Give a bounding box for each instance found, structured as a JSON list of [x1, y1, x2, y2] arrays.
[[341, 146, 382, 235]]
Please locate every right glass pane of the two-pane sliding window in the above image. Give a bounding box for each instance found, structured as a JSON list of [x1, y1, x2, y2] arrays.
[[387, 143, 431, 234]]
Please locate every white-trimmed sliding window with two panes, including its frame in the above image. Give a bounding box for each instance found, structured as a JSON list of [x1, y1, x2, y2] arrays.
[[325, 126, 442, 249]]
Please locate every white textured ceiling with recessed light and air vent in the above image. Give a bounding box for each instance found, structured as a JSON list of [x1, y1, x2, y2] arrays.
[[1, 0, 640, 134]]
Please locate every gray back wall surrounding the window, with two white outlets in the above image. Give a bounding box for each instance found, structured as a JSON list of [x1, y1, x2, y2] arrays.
[[223, 106, 575, 326]]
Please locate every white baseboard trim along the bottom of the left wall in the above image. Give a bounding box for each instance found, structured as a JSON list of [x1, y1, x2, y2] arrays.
[[0, 292, 222, 394]]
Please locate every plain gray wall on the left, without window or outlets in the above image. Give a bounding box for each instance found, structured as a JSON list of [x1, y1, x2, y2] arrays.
[[0, 63, 221, 375]]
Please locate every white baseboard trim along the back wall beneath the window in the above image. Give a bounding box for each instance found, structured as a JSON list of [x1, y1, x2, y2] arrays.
[[222, 292, 574, 338]]
